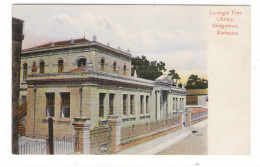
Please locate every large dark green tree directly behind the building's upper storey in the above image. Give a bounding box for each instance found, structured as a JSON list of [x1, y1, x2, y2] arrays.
[[131, 56, 166, 80]]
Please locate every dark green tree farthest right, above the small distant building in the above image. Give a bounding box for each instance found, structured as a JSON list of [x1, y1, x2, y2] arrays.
[[185, 74, 208, 89]]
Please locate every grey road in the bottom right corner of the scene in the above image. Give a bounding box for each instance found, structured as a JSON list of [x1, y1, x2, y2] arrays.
[[159, 126, 208, 155]]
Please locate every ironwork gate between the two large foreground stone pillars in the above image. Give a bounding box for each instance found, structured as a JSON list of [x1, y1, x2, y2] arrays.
[[90, 127, 111, 154]]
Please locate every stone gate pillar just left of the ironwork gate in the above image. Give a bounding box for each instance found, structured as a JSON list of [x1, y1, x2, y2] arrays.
[[72, 117, 91, 154]]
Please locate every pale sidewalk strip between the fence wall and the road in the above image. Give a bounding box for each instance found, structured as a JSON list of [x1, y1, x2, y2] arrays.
[[117, 120, 208, 155]]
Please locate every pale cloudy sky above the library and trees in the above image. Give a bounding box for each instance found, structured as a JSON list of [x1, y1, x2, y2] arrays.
[[12, 5, 207, 83]]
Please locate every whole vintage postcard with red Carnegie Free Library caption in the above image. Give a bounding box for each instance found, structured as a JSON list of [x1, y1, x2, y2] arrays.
[[12, 4, 250, 155]]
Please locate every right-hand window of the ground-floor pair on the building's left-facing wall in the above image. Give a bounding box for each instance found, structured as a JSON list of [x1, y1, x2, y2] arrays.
[[61, 93, 70, 118]]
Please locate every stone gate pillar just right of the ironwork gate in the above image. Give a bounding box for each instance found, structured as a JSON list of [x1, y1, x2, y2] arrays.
[[108, 116, 122, 154]]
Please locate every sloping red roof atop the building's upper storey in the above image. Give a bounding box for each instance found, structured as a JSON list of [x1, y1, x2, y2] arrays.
[[23, 38, 90, 51]]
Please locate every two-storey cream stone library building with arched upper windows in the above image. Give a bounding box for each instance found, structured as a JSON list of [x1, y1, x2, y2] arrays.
[[20, 36, 186, 138]]
